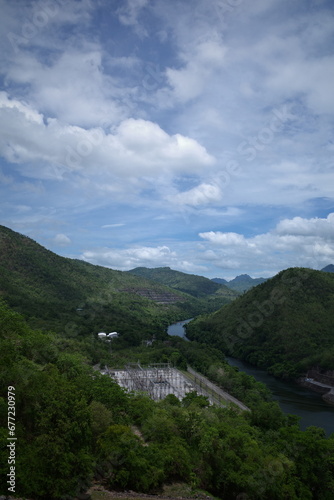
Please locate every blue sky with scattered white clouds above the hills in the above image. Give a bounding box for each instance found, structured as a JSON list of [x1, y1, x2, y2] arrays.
[[0, 0, 334, 279]]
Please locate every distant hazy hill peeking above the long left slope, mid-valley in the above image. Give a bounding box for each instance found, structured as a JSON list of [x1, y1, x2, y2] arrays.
[[129, 267, 237, 299]]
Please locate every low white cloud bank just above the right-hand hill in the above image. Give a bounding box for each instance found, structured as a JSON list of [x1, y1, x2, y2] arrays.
[[199, 213, 334, 271]]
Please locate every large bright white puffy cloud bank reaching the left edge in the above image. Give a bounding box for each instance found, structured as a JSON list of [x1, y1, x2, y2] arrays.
[[0, 92, 214, 183]]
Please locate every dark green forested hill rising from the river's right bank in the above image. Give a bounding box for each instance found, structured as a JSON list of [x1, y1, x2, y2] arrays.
[[187, 268, 334, 378]]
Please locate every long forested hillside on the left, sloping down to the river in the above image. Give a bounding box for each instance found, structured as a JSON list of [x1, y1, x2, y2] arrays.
[[0, 226, 213, 338]]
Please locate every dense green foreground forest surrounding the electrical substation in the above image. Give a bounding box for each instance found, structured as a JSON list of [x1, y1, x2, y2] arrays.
[[0, 303, 334, 500]]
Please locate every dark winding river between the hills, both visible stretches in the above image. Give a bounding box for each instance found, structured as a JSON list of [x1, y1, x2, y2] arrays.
[[167, 319, 334, 435]]
